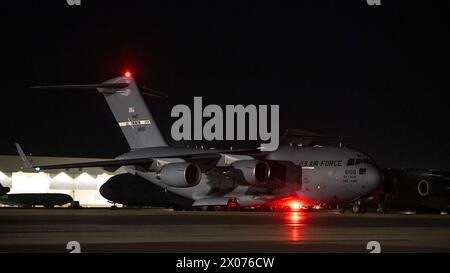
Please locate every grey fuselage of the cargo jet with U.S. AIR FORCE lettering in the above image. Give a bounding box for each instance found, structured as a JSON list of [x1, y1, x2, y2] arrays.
[[114, 146, 381, 206]]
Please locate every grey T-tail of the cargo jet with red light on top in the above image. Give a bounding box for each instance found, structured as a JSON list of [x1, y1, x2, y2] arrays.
[[33, 75, 167, 149]]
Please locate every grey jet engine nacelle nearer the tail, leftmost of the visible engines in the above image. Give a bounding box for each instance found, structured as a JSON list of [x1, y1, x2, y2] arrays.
[[157, 162, 202, 188]]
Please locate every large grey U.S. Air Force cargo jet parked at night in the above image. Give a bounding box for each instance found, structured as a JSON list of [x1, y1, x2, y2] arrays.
[[16, 73, 381, 208]]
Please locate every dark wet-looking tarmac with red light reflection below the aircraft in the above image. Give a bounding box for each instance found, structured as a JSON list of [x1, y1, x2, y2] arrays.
[[0, 208, 450, 253]]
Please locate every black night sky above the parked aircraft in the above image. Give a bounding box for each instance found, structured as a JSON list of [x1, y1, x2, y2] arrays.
[[0, 0, 450, 169]]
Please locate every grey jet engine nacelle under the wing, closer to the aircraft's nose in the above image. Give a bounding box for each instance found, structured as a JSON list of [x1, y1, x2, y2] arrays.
[[231, 160, 270, 185]]
